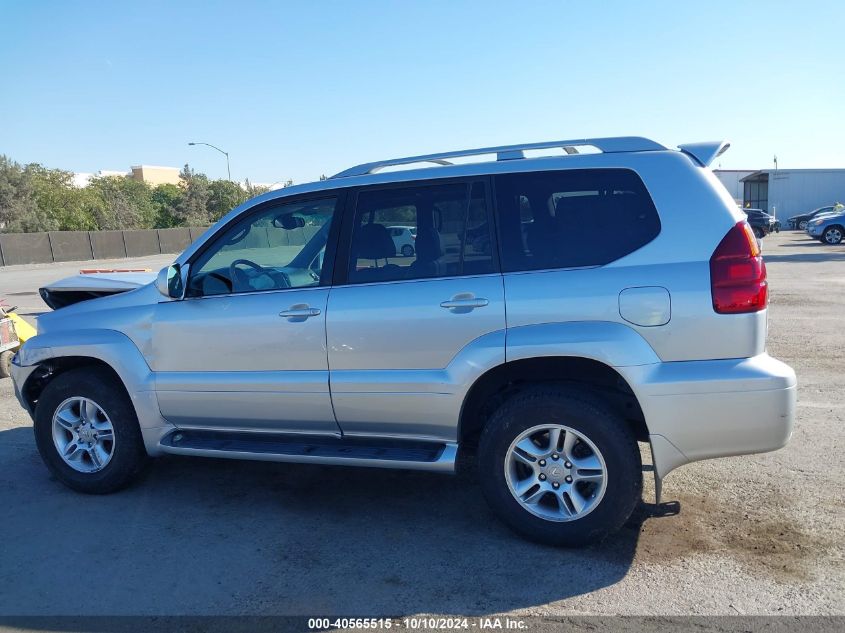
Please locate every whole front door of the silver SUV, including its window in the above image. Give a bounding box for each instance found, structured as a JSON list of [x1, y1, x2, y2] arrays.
[[151, 197, 340, 434]]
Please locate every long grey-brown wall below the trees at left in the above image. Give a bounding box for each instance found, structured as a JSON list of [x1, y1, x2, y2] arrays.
[[0, 227, 206, 266]]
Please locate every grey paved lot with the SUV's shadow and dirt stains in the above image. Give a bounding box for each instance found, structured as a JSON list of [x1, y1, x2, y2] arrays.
[[0, 232, 845, 623]]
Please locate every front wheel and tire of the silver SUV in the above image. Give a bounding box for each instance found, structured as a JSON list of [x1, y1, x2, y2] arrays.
[[35, 368, 148, 494]]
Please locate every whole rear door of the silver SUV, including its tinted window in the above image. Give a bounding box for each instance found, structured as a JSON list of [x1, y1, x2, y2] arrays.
[[327, 179, 505, 441]]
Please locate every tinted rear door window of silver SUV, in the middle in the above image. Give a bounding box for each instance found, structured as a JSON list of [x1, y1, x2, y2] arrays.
[[349, 182, 493, 283]]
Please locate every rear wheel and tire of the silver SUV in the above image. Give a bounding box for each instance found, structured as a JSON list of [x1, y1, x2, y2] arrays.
[[478, 385, 642, 547]]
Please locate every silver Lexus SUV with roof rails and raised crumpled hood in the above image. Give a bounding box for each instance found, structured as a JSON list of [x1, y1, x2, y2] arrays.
[[13, 137, 796, 545]]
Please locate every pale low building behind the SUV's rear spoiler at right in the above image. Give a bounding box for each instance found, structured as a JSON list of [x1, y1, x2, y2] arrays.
[[713, 169, 845, 219]]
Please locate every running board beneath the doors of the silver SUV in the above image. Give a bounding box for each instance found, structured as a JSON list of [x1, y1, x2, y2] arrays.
[[159, 429, 458, 474]]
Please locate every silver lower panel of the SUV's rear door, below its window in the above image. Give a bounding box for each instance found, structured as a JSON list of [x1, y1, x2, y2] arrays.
[[327, 274, 505, 440]]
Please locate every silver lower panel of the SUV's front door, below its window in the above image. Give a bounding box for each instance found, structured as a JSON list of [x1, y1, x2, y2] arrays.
[[150, 288, 339, 433]]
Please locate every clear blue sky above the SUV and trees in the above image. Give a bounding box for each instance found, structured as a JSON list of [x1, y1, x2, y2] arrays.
[[0, 0, 845, 183]]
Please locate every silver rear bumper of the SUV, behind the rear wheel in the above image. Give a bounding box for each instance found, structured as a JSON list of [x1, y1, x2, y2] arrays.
[[629, 354, 797, 477]]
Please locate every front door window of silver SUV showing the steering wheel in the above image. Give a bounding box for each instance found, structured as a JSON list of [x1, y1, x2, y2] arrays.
[[187, 197, 337, 297]]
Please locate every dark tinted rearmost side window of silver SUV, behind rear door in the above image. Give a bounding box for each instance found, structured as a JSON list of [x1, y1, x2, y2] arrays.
[[495, 169, 660, 272]]
